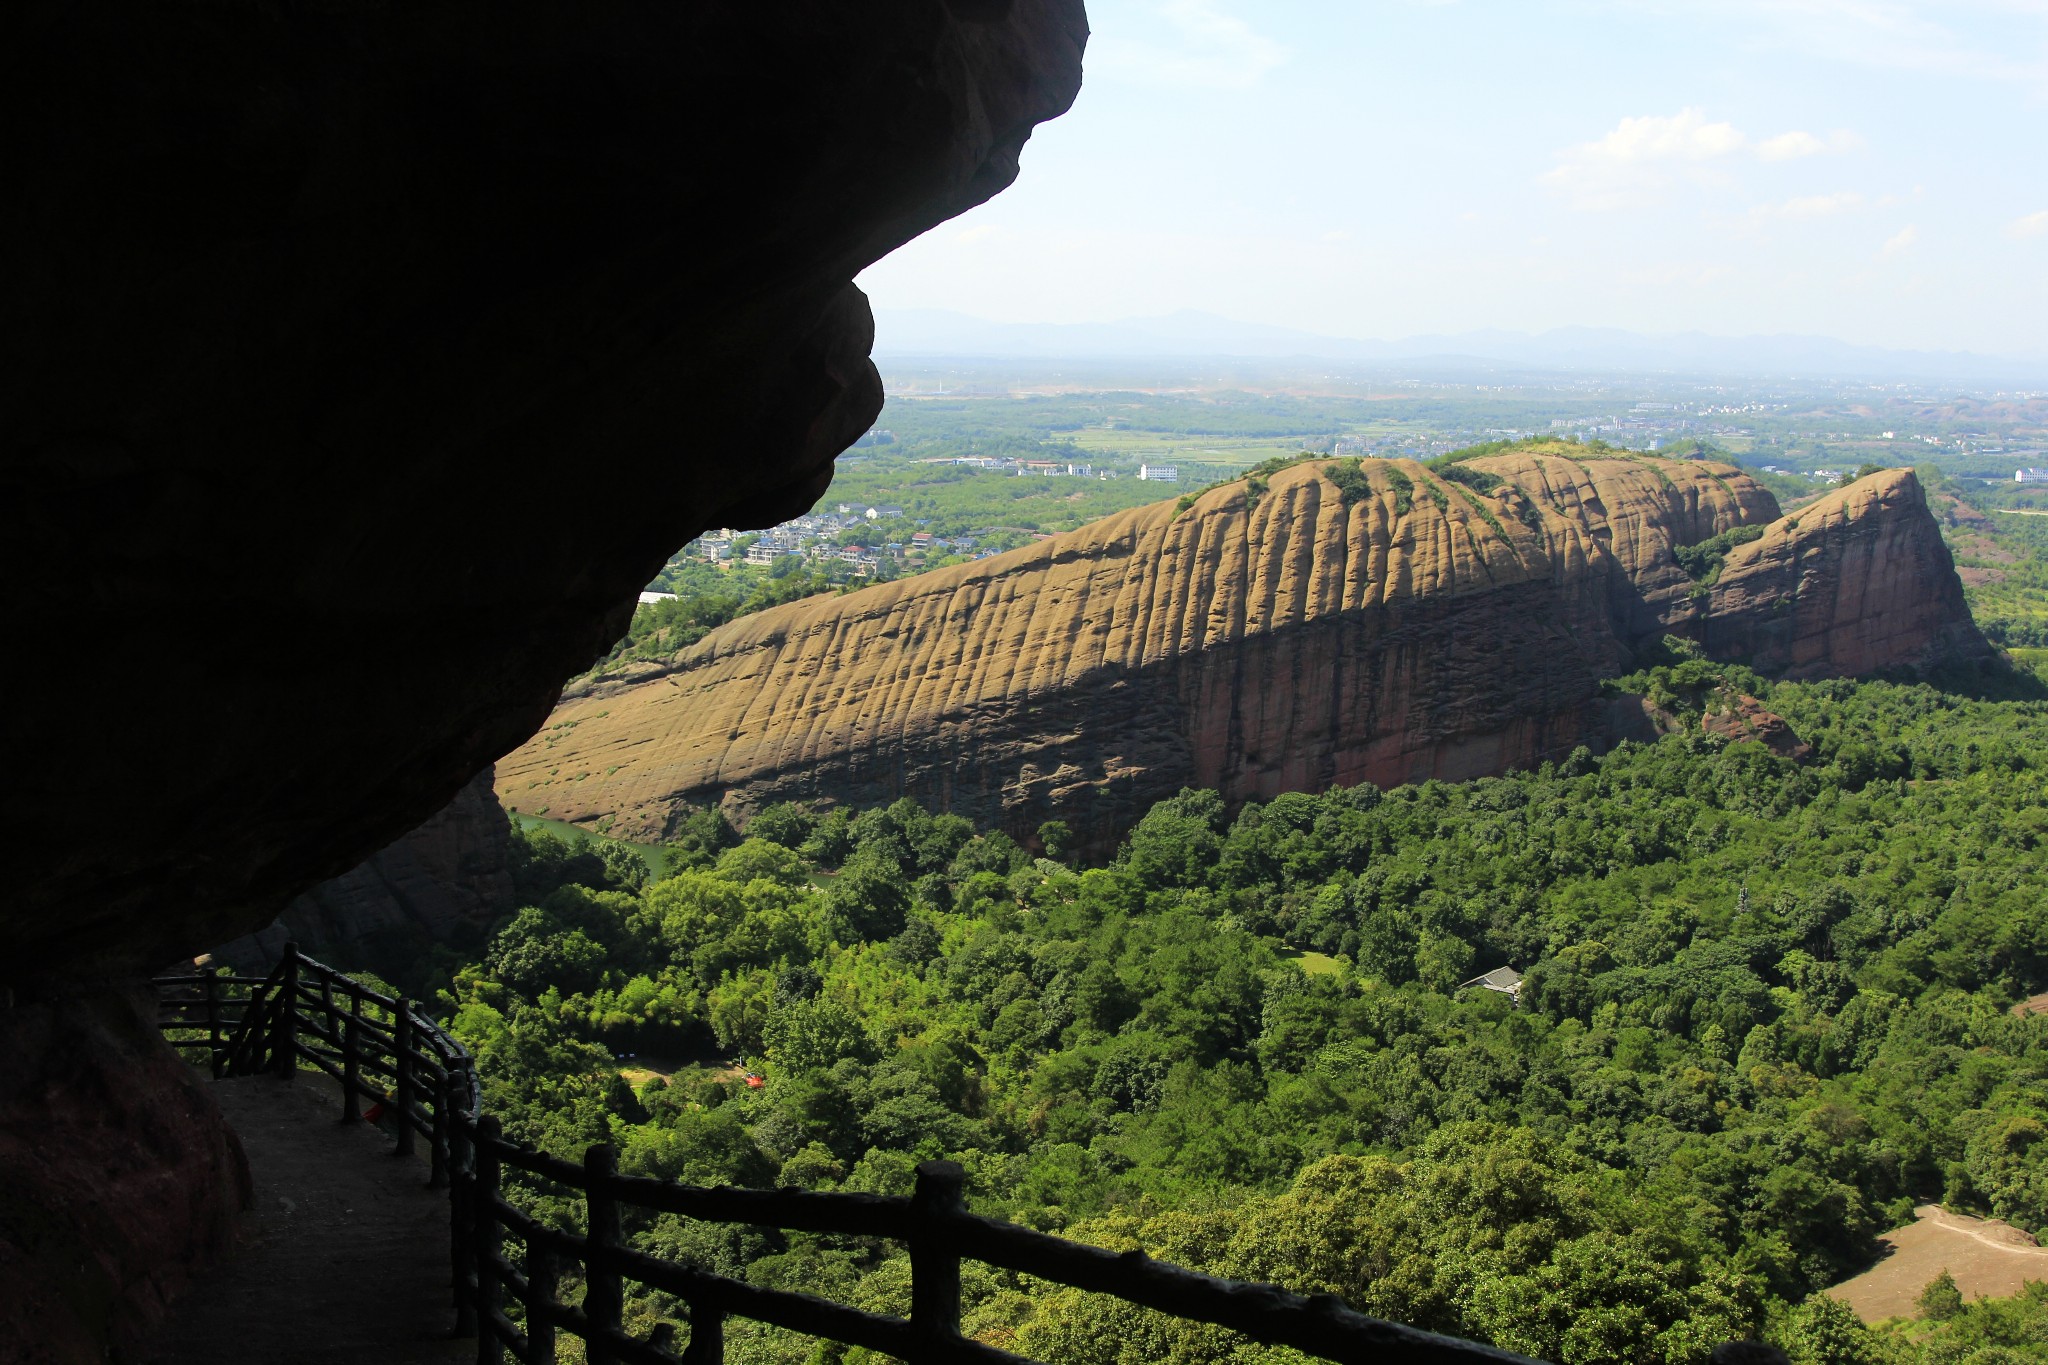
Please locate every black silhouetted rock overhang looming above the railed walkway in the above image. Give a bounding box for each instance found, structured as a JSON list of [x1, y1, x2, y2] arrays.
[[0, 0, 1085, 1359]]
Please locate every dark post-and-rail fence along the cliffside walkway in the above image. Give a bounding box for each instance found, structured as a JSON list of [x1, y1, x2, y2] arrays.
[[158, 943, 1530, 1365]]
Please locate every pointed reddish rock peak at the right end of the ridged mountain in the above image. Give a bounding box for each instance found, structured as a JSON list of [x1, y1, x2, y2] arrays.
[[1673, 469, 1995, 677]]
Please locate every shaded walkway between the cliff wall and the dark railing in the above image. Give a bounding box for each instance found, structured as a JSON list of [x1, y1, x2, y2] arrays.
[[143, 1072, 475, 1365]]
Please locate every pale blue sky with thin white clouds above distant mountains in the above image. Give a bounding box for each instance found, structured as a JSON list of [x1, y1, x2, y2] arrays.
[[860, 0, 2048, 356]]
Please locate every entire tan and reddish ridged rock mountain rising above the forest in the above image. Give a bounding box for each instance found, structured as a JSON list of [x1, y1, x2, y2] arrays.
[[498, 454, 1989, 843]]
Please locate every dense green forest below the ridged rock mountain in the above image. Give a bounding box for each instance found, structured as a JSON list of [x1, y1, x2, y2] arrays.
[[411, 657, 2048, 1365]]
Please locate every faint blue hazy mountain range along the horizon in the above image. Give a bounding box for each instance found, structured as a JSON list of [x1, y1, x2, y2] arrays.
[[874, 309, 2048, 385]]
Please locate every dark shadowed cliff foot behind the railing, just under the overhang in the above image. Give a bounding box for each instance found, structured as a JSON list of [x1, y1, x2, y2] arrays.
[[213, 767, 514, 978]]
